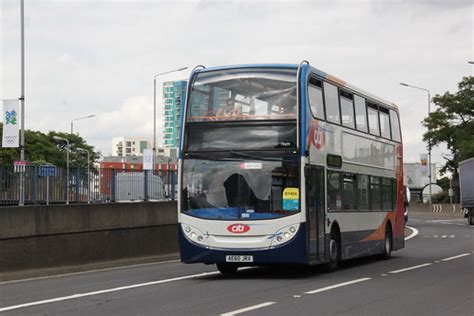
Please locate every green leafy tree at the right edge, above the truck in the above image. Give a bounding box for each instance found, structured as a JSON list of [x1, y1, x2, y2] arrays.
[[423, 76, 474, 201]]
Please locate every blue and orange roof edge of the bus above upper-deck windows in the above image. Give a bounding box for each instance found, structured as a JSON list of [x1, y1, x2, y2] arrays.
[[199, 64, 398, 110]]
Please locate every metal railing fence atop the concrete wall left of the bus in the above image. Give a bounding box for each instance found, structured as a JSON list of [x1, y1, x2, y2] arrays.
[[0, 166, 177, 206]]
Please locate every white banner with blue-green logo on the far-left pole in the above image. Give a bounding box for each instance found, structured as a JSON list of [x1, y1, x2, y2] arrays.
[[2, 100, 20, 148]]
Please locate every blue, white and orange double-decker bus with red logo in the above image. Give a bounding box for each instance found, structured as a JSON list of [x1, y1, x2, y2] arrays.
[[178, 61, 404, 273]]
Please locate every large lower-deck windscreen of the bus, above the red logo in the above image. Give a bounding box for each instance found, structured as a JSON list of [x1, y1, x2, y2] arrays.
[[182, 159, 300, 220]]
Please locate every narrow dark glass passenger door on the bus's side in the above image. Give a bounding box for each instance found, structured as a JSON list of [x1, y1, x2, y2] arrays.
[[305, 165, 325, 263]]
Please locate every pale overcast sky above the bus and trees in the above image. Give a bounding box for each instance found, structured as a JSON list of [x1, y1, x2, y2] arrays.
[[0, 0, 474, 167]]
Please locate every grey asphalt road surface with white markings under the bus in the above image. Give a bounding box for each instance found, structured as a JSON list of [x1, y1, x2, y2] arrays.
[[0, 214, 474, 316]]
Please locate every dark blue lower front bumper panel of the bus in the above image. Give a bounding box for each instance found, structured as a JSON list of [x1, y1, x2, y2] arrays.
[[179, 223, 308, 266]]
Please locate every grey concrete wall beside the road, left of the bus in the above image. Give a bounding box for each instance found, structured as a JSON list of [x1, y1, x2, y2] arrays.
[[0, 202, 178, 273]]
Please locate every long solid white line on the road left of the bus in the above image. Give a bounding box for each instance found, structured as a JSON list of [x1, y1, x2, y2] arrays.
[[0, 271, 220, 312]]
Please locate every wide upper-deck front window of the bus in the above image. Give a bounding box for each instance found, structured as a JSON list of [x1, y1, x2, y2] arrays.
[[187, 68, 297, 122]]
